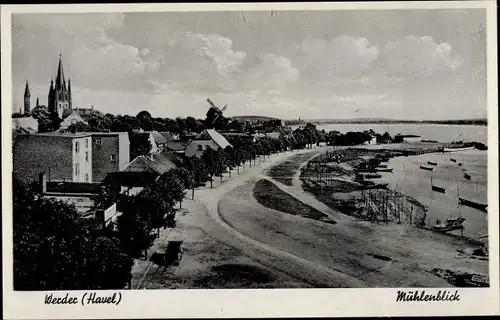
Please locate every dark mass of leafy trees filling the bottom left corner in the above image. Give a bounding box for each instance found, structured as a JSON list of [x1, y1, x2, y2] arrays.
[[13, 180, 132, 290]]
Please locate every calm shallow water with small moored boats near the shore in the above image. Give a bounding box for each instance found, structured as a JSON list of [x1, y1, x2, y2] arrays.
[[380, 150, 488, 237]]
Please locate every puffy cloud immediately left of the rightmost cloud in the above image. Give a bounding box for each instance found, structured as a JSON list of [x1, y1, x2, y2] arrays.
[[293, 35, 379, 79]]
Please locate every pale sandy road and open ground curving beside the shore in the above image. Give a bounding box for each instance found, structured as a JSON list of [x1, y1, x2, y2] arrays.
[[173, 150, 488, 288]]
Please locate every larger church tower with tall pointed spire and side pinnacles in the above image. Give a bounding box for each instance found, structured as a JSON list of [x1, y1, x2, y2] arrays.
[[48, 55, 72, 119]]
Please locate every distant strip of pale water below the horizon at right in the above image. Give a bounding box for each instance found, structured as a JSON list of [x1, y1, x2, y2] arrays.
[[310, 124, 488, 145]]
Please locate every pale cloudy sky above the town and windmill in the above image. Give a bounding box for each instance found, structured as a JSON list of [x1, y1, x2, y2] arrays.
[[12, 9, 487, 120]]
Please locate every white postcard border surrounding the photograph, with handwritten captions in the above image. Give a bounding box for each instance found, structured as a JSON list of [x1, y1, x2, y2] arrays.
[[1, 0, 500, 319]]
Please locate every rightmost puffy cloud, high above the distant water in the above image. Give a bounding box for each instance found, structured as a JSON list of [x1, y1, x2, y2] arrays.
[[380, 36, 463, 76]]
